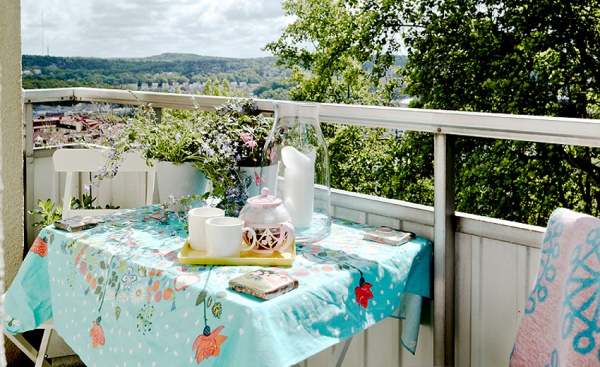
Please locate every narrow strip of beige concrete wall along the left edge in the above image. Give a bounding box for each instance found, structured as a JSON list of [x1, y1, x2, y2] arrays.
[[0, 0, 24, 366]]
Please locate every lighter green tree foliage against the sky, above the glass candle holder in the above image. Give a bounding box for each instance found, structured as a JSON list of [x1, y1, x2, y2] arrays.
[[265, 0, 406, 104]]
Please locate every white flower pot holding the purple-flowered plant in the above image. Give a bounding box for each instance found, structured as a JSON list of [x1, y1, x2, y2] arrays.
[[156, 162, 208, 203]]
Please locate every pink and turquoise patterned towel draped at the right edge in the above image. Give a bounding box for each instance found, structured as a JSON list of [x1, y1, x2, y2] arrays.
[[510, 209, 600, 367]]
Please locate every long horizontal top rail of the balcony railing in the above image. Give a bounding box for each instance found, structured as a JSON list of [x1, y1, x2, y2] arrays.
[[23, 88, 600, 147]]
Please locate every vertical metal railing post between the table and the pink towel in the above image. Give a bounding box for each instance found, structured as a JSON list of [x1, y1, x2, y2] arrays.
[[433, 134, 455, 366]]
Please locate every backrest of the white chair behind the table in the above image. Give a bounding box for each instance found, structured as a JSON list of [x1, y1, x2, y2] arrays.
[[52, 149, 156, 218]]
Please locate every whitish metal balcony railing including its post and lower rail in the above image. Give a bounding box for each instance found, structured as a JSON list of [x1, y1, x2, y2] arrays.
[[23, 88, 600, 366]]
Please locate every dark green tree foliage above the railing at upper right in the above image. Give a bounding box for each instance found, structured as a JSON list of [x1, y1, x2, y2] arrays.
[[403, 0, 600, 118]]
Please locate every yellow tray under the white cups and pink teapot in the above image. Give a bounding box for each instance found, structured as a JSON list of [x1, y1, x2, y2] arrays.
[[177, 241, 296, 266]]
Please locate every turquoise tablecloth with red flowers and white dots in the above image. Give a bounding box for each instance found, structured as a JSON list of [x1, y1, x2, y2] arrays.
[[4, 206, 432, 367]]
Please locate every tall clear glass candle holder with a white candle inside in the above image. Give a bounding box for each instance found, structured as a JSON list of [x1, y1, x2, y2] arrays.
[[261, 102, 331, 242]]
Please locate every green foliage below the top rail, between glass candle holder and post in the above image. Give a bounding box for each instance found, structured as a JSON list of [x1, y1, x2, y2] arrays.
[[327, 125, 433, 205]]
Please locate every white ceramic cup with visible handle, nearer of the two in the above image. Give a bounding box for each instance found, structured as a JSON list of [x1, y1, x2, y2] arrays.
[[206, 217, 257, 257]]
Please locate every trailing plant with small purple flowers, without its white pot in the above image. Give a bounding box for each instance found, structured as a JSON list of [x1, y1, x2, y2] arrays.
[[98, 99, 272, 215]]
